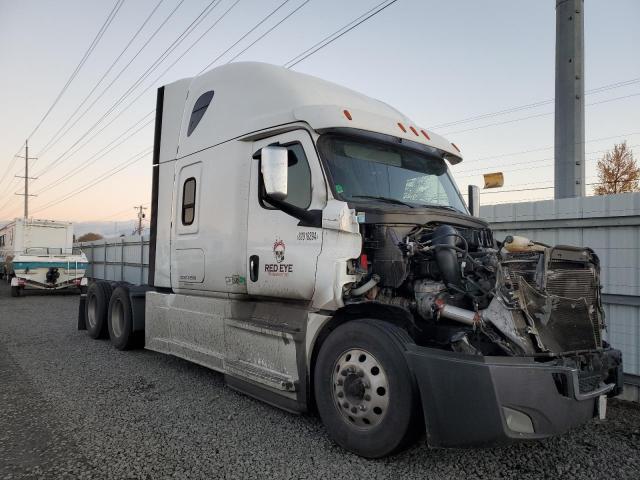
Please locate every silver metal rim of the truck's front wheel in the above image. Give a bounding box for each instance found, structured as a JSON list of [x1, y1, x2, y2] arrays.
[[331, 349, 390, 430]]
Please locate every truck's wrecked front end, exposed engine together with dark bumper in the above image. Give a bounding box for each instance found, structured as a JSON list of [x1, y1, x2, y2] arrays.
[[344, 222, 622, 446]]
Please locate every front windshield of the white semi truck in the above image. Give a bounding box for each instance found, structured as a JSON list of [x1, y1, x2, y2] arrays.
[[320, 136, 468, 214]]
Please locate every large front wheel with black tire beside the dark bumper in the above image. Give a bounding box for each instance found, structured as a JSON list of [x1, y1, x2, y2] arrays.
[[314, 319, 424, 458]]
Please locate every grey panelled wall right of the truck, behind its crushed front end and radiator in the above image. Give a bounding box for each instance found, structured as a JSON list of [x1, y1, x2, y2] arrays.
[[480, 193, 640, 399]]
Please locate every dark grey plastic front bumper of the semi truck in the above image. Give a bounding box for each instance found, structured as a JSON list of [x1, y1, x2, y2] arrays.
[[406, 345, 622, 447]]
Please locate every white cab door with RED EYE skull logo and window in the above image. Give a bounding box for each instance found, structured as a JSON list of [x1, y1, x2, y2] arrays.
[[246, 130, 327, 300]]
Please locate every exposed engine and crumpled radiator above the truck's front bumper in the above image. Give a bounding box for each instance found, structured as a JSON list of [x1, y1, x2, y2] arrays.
[[345, 223, 604, 357]]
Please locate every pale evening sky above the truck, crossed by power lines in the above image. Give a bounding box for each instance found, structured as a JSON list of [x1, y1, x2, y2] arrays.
[[0, 0, 640, 221]]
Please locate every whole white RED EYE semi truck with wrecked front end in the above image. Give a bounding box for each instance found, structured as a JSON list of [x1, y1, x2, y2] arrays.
[[79, 63, 622, 457]]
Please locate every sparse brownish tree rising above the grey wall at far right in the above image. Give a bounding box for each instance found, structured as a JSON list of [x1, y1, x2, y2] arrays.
[[594, 141, 640, 195]]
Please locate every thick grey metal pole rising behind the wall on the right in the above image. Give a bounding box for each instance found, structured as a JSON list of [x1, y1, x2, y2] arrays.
[[554, 0, 585, 198]]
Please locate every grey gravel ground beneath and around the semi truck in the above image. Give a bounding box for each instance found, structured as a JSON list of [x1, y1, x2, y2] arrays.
[[0, 284, 640, 480]]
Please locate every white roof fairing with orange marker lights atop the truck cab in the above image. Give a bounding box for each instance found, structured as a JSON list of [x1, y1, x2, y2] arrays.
[[165, 62, 462, 164]]
